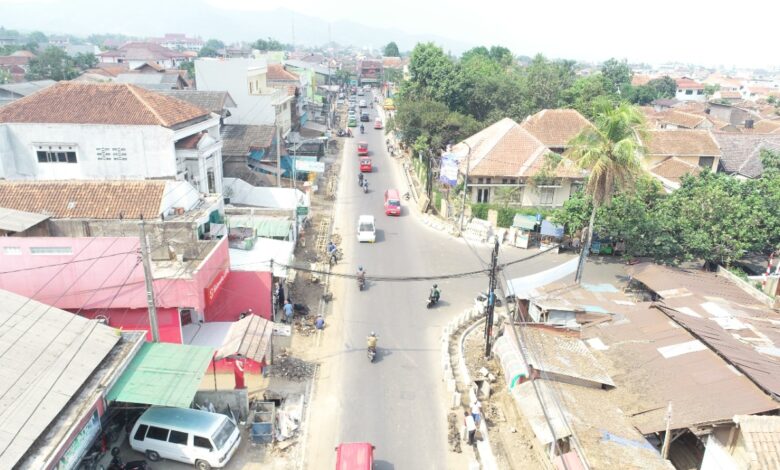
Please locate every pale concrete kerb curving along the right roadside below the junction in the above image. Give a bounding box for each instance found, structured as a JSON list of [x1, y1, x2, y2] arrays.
[[442, 308, 498, 470]]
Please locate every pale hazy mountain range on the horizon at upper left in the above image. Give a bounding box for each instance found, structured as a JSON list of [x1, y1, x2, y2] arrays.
[[0, 0, 471, 54]]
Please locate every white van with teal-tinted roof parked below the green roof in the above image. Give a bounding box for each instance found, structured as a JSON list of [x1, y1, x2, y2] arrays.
[[129, 406, 241, 470]]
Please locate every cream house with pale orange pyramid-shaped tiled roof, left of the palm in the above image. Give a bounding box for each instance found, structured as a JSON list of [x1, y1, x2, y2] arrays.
[[452, 118, 585, 207]]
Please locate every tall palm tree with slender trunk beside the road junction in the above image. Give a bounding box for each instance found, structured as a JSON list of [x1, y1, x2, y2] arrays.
[[566, 101, 645, 283]]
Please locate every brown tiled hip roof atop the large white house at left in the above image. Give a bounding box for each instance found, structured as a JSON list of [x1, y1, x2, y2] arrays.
[[0, 82, 209, 128]]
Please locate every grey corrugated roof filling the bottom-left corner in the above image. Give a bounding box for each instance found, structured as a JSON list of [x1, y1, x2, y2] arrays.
[[0, 290, 119, 468]]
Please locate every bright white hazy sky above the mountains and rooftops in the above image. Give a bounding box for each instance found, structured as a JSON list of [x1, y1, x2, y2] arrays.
[[0, 0, 780, 68]]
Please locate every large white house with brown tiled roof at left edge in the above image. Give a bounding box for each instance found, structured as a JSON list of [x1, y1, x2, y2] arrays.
[[0, 82, 222, 193]]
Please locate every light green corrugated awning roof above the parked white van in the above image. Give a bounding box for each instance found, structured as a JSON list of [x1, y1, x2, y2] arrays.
[[108, 343, 214, 408]]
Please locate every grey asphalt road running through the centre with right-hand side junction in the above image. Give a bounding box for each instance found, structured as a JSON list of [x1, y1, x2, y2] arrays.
[[307, 89, 568, 470]]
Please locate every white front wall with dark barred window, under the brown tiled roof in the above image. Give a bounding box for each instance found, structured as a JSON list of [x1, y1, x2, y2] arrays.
[[0, 123, 177, 180]]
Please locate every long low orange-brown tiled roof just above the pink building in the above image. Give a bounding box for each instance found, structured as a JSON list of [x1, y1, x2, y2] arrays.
[[0, 180, 166, 220]]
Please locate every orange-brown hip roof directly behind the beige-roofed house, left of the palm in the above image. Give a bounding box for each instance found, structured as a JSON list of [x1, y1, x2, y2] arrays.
[[520, 109, 593, 148]]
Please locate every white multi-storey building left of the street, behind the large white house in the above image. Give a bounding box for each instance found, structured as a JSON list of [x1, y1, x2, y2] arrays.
[[195, 58, 294, 137]]
